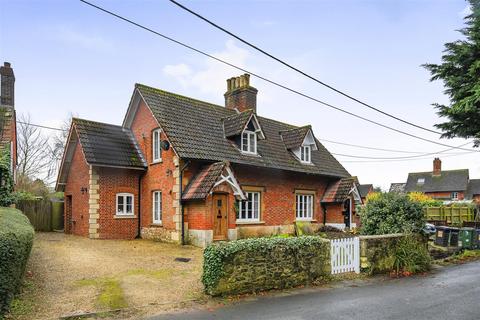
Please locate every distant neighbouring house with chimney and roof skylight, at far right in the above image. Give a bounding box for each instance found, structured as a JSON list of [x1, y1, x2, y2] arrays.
[[398, 158, 480, 201]]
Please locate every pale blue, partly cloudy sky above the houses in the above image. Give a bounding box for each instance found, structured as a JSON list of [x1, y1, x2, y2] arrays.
[[0, 0, 480, 189]]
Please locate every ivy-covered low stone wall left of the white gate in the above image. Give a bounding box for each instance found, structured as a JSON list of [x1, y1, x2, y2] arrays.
[[202, 236, 330, 295]]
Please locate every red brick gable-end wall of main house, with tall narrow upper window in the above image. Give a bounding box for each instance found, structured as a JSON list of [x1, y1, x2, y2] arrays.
[[131, 101, 176, 230]]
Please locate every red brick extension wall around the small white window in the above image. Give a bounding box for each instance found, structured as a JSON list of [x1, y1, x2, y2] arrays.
[[96, 168, 143, 239]]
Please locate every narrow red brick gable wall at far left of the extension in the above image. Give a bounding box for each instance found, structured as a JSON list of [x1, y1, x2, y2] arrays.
[[64, 143, 89, 236]]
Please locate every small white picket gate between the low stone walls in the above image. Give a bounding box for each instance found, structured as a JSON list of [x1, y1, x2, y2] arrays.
[[330, 237, 360, 274]]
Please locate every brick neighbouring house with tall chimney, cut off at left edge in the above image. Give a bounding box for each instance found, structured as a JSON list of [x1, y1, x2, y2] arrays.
[[0, 62, 17, 183]]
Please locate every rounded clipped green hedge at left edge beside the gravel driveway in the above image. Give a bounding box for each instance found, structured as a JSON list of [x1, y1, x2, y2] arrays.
[[0, 208, 34, 318]]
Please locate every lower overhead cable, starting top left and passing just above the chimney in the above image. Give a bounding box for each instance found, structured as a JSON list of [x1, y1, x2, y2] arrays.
[[79, 0, 480, 152]]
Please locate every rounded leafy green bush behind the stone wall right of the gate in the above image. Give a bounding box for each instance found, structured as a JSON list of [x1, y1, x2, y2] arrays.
[[360, 193, 425, 235]]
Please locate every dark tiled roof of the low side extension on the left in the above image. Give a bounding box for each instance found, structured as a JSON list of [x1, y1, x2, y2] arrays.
[[72, 118, 146, 168]]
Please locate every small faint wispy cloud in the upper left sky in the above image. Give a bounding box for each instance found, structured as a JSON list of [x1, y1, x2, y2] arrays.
[[51, 26, 113, 51]]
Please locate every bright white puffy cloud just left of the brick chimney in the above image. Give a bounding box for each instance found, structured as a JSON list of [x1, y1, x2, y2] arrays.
[[163, 40, 253, 97]]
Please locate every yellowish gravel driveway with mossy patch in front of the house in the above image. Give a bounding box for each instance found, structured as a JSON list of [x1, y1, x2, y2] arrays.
[[9, 233, 205, 319]]
